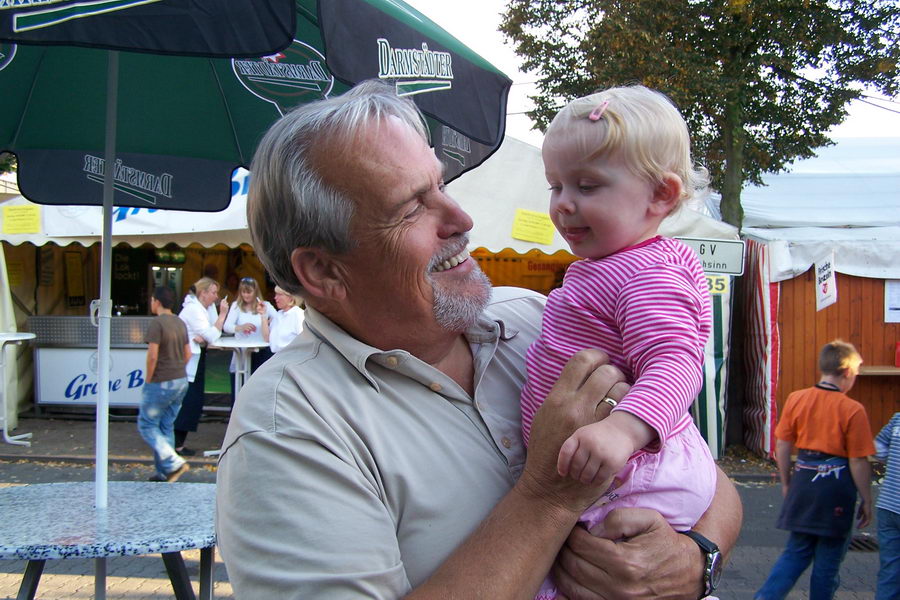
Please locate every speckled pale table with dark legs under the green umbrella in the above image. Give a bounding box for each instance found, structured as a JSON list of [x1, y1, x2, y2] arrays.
[[0, 481, 216, 600]]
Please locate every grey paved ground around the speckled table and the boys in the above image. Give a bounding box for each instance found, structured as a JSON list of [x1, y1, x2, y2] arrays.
[[0, 417, 878, 600]]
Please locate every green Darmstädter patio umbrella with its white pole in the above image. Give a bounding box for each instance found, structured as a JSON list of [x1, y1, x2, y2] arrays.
[[0, 0, 511, 507]]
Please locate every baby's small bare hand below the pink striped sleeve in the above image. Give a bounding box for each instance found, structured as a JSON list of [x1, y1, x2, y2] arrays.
[[557, 420, 635, 485]]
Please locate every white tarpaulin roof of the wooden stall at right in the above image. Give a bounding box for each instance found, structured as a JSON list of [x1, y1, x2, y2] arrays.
[[741, 138, 900, 281]]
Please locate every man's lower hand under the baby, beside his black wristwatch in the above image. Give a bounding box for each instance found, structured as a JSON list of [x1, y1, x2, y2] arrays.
[[552, 508, 703, 600]]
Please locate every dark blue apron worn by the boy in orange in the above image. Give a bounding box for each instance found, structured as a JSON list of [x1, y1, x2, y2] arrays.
[[777, 450, 856, 537]]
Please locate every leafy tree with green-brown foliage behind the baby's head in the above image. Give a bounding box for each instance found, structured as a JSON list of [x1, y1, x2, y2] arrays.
[[500, 0, 900, 226]]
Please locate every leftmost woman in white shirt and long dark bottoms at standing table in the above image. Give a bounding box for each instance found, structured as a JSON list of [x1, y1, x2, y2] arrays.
[[174, 277, 228, 456]]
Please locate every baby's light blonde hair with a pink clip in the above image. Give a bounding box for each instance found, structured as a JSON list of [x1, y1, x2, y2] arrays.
[[544, 85, 709, 206]]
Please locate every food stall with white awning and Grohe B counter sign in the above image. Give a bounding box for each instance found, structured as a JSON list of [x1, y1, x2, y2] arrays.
[[0, 171, 270, 412]]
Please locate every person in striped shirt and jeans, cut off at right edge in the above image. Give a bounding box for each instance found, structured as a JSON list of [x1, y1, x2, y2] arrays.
[[875, 412, 900, 600]]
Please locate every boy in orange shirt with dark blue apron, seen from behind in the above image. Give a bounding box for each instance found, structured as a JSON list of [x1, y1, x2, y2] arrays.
[[754, 340, 875, 600]]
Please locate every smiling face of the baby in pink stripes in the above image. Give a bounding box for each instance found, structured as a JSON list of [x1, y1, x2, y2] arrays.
[[542, 137, 671, 259]]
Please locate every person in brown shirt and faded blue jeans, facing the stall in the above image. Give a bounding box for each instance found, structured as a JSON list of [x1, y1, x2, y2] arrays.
[[137, 287, 191, 482]]
